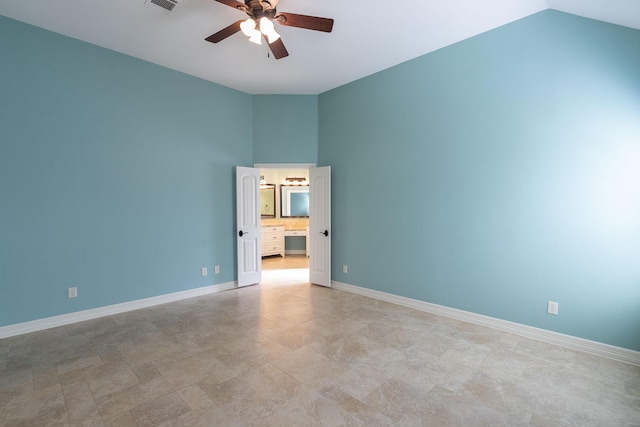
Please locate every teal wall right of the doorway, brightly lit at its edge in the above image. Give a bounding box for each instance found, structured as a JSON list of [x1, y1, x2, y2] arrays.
[[318, 11, 640, 350]]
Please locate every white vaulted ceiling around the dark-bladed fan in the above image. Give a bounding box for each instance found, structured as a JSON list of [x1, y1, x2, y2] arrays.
[[0, 0, 640, 94]]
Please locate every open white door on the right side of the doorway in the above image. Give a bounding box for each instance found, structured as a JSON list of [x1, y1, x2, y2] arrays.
[[309, 166, 331, 287]]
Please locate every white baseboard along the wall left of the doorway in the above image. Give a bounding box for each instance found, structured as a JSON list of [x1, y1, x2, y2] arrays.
[[0, 281, 237, 339]]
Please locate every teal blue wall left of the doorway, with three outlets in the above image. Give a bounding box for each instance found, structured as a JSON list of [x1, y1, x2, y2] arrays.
[[0, 17, 253, 326]]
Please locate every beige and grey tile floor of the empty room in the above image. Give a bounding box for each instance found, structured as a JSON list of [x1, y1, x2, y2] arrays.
[[0, 260, 640, 427]]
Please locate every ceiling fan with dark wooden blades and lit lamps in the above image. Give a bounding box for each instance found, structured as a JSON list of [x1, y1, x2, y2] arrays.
[[205, 0, 333, 59]]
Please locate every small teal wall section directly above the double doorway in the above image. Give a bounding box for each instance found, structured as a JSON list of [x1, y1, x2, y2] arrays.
[[253, 95, 318, 163]]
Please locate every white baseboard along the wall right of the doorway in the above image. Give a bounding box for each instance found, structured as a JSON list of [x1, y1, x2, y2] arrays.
[[331, 281, 640, 366]]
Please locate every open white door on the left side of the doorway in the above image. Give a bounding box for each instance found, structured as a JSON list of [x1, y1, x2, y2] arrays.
[[236, 166, 262, 287]]
